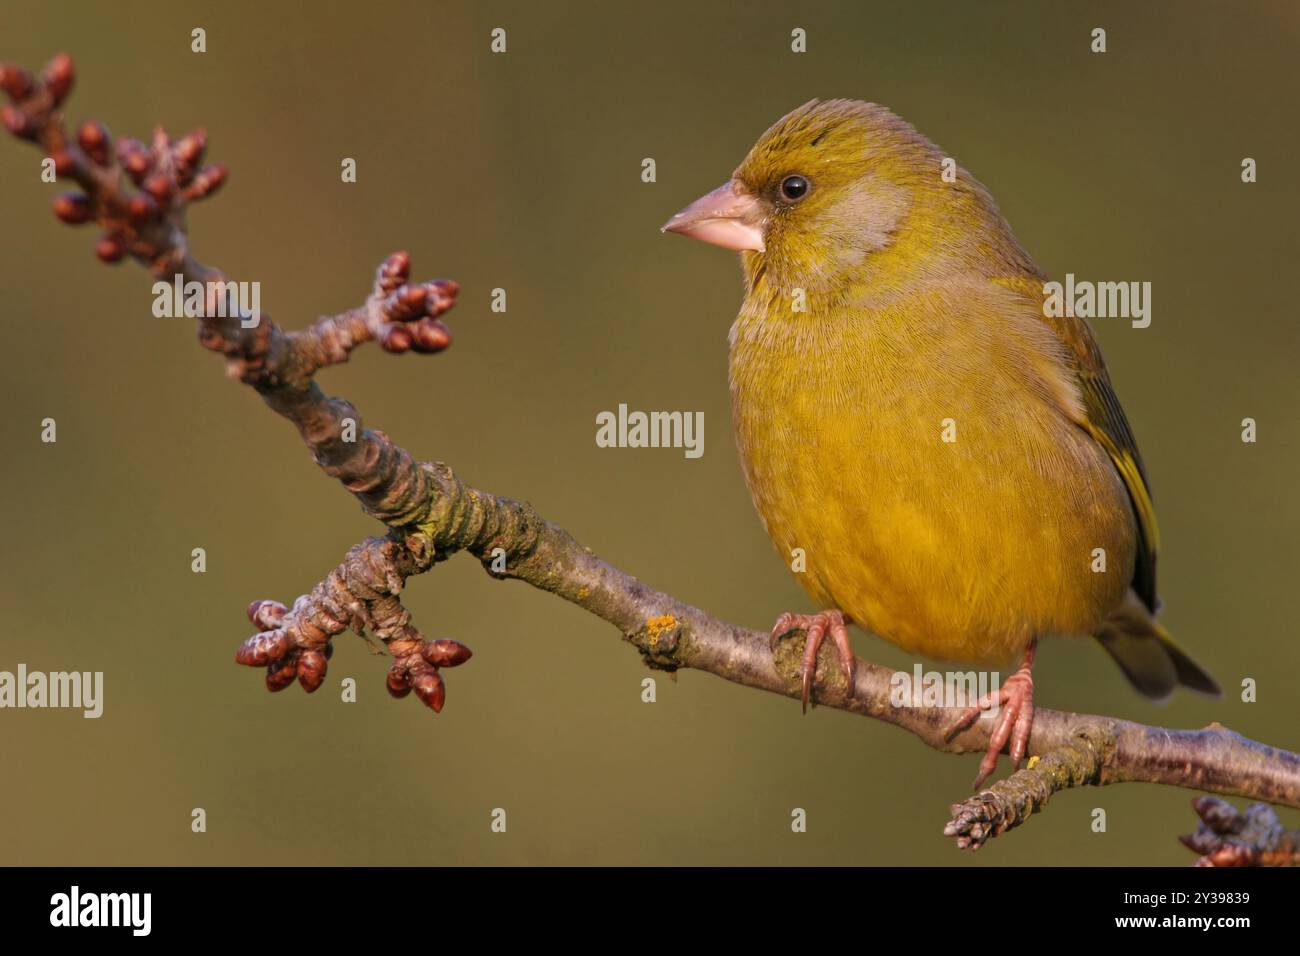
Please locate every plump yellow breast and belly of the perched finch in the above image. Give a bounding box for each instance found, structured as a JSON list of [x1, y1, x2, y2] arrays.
[[731, 287, 1134, 661]]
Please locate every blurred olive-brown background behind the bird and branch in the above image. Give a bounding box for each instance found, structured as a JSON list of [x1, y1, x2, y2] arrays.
[[0, 0, 1300, 865]]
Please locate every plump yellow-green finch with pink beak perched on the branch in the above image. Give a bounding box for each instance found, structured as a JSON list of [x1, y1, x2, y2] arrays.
[[662, 99, 1219, 788]]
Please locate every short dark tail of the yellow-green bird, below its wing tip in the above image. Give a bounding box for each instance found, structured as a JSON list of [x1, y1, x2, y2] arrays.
[[1097, 591, 1222, 700]]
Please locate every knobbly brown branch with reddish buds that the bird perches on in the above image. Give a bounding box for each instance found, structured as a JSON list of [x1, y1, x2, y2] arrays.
[[0, 55, 1300, 864]]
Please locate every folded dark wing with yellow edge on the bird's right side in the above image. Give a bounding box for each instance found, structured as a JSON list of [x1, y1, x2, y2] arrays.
[[993, 277, 1160, 613]]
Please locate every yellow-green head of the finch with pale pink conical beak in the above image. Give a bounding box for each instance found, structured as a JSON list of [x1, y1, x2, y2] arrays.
[[663, 100, 1001, 289]]
